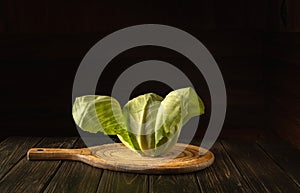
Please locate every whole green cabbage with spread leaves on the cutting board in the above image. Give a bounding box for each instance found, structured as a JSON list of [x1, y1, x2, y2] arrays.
[[72, 87, 204, 156]]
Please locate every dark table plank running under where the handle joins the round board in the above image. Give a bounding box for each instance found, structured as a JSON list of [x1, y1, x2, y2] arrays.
[[44, 139, 102, 193]]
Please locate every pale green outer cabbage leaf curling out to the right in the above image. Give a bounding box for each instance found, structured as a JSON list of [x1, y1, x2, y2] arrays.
[[155, 87, 204, 155]]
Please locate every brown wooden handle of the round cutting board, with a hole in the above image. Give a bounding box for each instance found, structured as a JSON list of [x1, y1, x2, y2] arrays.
[[27, 148, 91, 160]]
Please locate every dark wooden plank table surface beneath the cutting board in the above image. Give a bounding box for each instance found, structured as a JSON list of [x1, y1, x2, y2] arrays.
[[0, 137, 300, 193]]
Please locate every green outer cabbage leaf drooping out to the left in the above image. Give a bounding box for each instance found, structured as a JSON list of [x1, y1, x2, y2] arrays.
[[72, 95, 135, 150]]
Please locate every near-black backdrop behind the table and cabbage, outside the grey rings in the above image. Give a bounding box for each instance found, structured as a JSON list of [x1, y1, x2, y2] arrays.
[[0, 0, 300, 146]]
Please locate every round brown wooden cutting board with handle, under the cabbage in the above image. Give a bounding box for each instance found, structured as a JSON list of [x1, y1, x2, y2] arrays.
[[27, 143, 214, 174]]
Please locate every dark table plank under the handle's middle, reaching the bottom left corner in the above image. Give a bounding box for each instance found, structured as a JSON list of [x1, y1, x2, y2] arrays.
[[0, 137, 77, 192]]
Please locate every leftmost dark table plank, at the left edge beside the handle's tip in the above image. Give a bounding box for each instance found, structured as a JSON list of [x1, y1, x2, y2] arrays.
[[0, 137, 41, 179]]
